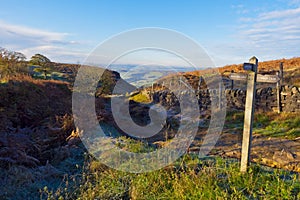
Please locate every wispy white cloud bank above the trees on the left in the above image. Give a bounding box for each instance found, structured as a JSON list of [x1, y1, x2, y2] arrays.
[[0, 20, 86, 63]]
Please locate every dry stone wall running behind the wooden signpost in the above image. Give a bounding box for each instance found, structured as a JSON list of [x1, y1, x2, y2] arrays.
[[152, 86, 300, 112]]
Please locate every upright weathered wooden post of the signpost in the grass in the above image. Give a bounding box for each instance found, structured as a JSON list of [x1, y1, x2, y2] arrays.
[[240, 57, 258, 172]]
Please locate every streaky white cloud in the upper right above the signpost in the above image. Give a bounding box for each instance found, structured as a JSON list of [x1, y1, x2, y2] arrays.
[[239, 8, 300, 45]]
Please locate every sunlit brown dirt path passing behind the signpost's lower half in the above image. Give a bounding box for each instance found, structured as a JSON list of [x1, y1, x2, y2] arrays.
[[200, 132, 300, 172]]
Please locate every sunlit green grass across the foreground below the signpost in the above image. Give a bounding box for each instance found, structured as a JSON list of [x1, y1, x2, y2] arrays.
[[41, 138, 300, 200]]
